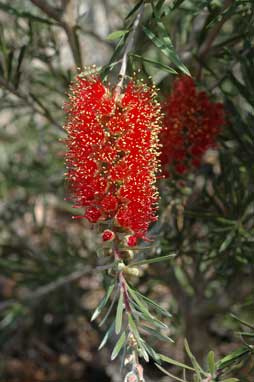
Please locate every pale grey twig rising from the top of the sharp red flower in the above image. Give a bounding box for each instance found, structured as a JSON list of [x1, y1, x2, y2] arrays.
[[115, 2, 145, 97]]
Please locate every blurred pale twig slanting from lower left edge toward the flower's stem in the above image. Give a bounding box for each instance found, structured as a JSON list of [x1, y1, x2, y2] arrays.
[[0, 266, 91, 311]]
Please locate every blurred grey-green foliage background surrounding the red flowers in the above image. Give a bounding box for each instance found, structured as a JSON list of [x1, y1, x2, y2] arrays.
[[0, 0, 254, 382]]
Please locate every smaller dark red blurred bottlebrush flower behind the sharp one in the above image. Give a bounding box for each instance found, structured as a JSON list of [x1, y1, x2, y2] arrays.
[[160, 76, 225, 175]]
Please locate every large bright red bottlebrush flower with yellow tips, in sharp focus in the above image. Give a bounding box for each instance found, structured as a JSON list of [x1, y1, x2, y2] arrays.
[[66, 74, 160, 245]]
